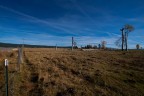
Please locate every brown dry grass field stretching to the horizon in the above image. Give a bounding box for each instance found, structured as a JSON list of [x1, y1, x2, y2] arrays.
[[0, 48, 144, 96]]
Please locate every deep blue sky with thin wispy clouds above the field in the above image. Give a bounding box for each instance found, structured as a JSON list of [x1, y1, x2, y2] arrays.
[[0, 0, 144, 48]]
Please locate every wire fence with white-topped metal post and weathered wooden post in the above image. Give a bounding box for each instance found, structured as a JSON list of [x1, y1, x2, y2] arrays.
[[0, 47, 23, 96]]
